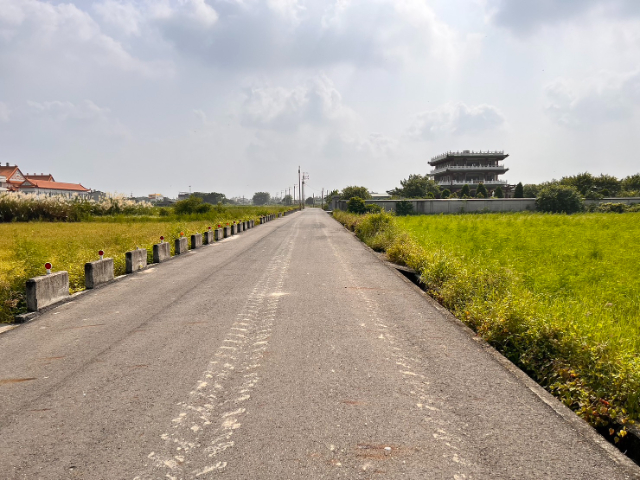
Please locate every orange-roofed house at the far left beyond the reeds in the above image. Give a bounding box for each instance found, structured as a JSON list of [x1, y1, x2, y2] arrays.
[[0, 163, 90, 198]]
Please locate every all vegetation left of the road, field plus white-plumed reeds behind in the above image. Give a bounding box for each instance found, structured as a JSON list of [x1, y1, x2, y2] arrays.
[[0, 194, 290, 323]]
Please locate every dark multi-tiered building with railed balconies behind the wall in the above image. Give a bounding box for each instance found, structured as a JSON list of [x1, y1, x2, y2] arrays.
[[429, 150, 509, 192]]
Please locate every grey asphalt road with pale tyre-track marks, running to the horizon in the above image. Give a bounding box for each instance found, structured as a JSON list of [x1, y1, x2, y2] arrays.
[[0, 210, 639, 480]]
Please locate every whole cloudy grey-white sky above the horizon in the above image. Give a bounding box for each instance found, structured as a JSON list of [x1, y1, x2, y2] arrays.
[[0, 0, 640, 197]]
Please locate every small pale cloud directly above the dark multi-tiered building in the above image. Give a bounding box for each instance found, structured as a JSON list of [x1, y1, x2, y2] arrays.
[[408, 103, 505, 140]]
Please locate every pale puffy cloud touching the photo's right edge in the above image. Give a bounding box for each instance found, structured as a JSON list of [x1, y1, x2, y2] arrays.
[[545, 70, 640, 127]]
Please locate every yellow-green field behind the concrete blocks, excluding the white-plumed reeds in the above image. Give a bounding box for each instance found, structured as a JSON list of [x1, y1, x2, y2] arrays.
[[0, 207, 289, 323]]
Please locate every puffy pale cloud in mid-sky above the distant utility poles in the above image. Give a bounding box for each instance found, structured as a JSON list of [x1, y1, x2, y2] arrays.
[[241, 75, 354, 130]]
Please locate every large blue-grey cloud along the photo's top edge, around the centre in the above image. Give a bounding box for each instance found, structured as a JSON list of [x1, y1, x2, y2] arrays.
[[155, 0, 456, 69]]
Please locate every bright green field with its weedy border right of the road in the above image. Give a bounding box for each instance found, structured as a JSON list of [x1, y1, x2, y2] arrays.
[[334, 211, 640, 442]]
